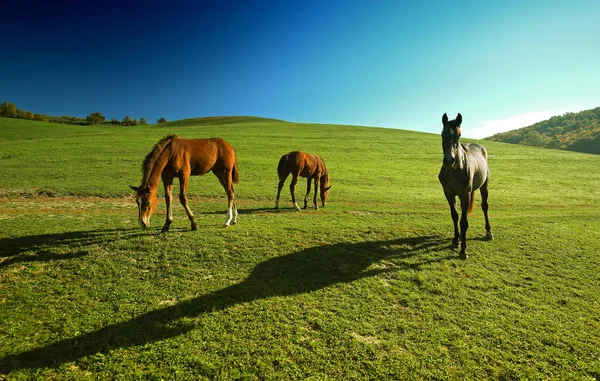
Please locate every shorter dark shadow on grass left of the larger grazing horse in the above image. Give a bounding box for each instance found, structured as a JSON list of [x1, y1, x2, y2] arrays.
[[0, 229, 141, 269]]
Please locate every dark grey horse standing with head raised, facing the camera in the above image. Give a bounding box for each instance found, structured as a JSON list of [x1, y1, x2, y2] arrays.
[[438, 114, 493, 259]]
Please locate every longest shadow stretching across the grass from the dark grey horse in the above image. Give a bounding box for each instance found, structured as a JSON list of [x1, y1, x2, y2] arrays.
[[0, 236, 454, 373]]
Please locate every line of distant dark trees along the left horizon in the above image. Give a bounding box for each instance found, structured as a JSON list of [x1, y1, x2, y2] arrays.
[[0, 102, 167, 126]]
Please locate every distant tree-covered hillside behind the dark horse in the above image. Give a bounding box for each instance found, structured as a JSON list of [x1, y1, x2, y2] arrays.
[[486, 107, 600, 154]]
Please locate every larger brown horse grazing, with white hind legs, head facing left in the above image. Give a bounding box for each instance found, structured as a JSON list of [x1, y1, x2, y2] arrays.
[[130, 135, 239, 232]]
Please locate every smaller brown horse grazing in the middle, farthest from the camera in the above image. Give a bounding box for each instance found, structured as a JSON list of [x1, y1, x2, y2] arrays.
[[275, 151, 331, 210]]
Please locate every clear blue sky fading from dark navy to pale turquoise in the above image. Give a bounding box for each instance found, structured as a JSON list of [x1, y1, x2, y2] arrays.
[[0, 0, 600, 137]]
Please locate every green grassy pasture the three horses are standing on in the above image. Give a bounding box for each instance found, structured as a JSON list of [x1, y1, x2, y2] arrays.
[[0, 118, 600, 380]]
